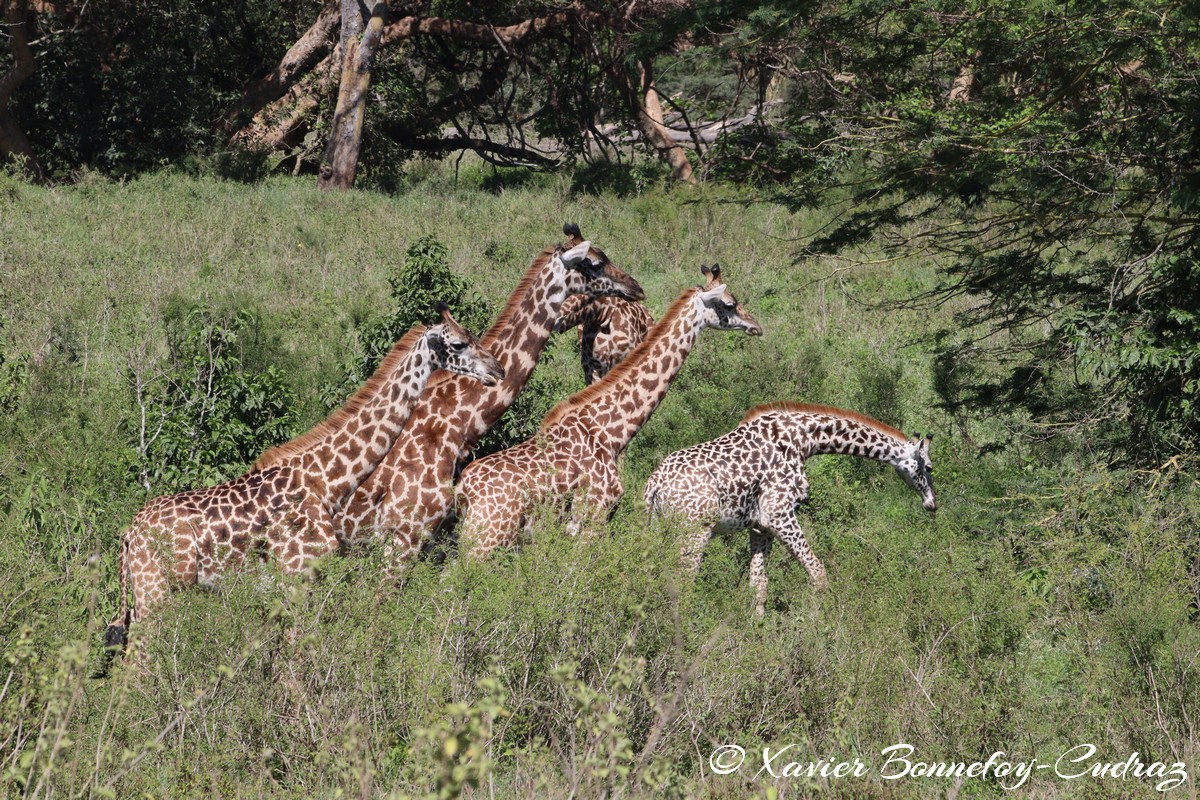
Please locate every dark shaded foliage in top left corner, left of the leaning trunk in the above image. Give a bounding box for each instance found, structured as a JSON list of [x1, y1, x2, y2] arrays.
[[15, 0, 319, 175]]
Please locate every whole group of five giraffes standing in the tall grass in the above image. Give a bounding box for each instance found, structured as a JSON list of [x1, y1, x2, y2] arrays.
[[104, 224, 936, 671]]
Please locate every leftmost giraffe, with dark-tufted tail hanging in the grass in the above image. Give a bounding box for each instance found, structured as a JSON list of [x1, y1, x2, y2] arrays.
[[96, 303, 504, 666]]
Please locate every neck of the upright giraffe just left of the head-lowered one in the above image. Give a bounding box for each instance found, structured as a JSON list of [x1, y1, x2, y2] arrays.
[[541, 289, 704, 453]]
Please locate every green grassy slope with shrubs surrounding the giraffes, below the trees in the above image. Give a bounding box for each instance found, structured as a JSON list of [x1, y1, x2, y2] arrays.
[[0, 165, 1200, 798]]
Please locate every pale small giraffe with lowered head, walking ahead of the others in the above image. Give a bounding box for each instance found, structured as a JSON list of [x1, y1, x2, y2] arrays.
[[644, 403, 937, 616]]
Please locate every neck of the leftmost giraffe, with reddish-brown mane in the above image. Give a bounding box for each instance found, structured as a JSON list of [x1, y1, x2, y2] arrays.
[[283, 332, 444, 512]]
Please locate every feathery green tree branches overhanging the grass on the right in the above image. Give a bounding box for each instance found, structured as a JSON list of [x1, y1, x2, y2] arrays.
[[700, 1, 1200, 455]]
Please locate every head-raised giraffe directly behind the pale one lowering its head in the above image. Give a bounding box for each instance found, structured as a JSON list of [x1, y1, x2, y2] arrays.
[[456, 266, 762, 558]]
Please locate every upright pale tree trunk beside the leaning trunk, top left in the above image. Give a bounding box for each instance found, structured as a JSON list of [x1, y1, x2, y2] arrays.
[[317, 0, 388, 191]]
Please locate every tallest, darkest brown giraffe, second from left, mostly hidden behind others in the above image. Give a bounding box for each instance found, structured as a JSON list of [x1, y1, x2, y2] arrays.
[[336, 223, 646, 570]]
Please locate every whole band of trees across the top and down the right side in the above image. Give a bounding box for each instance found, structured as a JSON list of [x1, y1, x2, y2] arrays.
[[0, 0, 1200, 458]]
